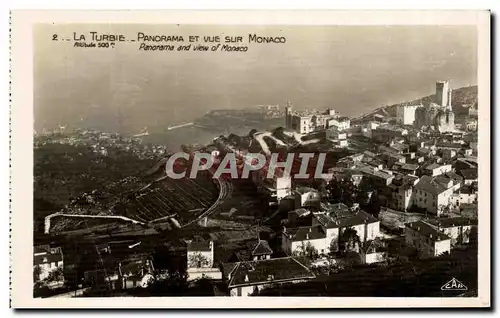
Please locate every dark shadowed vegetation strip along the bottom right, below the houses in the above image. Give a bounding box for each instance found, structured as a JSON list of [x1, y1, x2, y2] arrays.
[[260, 246, 478, 297]]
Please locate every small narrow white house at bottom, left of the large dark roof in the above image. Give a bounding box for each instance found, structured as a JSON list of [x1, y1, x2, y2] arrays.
[[187, 240, 222, 280]]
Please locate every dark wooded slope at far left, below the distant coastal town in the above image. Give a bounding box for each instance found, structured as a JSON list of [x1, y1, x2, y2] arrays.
[[34, 143, 153, 239]]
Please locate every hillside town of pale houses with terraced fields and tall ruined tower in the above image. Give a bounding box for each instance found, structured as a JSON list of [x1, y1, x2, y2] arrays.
[[33, 81, 478, 297]]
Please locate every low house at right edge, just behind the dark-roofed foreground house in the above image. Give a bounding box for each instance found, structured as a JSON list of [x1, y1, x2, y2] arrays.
[[429, 217, 477, 246]]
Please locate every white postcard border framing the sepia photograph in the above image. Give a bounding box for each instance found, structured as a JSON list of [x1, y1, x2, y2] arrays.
[[11, 10, 491, 308]]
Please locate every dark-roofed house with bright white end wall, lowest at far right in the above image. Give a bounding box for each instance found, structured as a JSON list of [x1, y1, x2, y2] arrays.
[[405, 221, 451, 258]]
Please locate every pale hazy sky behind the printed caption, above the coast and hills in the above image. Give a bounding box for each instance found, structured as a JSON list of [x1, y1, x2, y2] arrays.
[[34, 24, 477, 133]]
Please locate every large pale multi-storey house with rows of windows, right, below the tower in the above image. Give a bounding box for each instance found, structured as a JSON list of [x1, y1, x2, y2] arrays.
[[412, 176, 460, 216]]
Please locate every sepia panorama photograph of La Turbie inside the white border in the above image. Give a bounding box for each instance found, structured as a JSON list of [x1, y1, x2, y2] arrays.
[[9, 12, 490, 307]]
